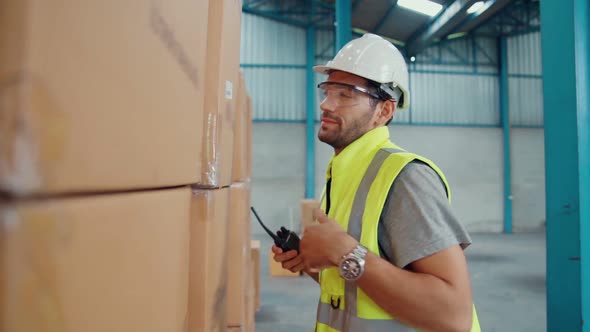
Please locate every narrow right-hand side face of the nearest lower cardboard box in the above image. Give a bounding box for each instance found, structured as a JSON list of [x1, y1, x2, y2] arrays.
[[188, 188, 229, 332]]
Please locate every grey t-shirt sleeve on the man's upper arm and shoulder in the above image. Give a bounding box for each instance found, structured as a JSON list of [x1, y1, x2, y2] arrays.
[[378, 161, 471, 268]]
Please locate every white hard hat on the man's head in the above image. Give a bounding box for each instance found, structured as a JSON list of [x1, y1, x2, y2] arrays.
[[313, 33, 410, 108]]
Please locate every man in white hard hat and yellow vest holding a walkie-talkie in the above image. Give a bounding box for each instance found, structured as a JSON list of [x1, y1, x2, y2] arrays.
[[273, 34, 480, 332]]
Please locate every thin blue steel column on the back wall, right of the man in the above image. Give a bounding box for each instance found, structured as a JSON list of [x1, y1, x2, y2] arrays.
[[499, 36, 512, 233]]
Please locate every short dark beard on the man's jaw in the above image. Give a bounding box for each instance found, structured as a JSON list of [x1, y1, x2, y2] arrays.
[[318, 110, 374, 150]]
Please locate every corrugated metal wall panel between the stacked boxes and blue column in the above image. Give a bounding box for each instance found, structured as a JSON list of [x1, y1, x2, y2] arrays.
[[240, 13, 306, 121]]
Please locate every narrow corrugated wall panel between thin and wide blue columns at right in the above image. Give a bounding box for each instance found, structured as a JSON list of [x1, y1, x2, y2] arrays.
[[507, 32, 543, 127]]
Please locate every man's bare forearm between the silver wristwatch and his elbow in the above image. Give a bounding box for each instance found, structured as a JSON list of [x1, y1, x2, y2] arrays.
[[357, 254, 472, 331]]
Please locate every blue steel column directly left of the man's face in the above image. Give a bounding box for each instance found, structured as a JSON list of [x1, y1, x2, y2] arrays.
[[305, 22, 316, 198]]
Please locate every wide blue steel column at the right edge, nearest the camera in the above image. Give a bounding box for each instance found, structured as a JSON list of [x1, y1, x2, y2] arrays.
[[540, 0, 590, 332]]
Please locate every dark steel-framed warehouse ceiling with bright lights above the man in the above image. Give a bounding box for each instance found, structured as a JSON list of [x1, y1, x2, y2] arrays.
[[242, 0, 540, 56]]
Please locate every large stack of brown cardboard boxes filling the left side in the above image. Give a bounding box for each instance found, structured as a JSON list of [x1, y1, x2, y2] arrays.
[[0, 0, 254, 332]]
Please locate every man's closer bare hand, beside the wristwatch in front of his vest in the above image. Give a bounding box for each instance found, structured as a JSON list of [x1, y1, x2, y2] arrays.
[[299, 209, 358, 270]]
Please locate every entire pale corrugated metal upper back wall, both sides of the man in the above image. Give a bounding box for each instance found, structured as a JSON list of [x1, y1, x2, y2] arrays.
[[241, 14, 543, 127]]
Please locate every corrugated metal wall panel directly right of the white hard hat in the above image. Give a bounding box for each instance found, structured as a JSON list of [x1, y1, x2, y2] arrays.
[[410, 38, 499, 126]]
